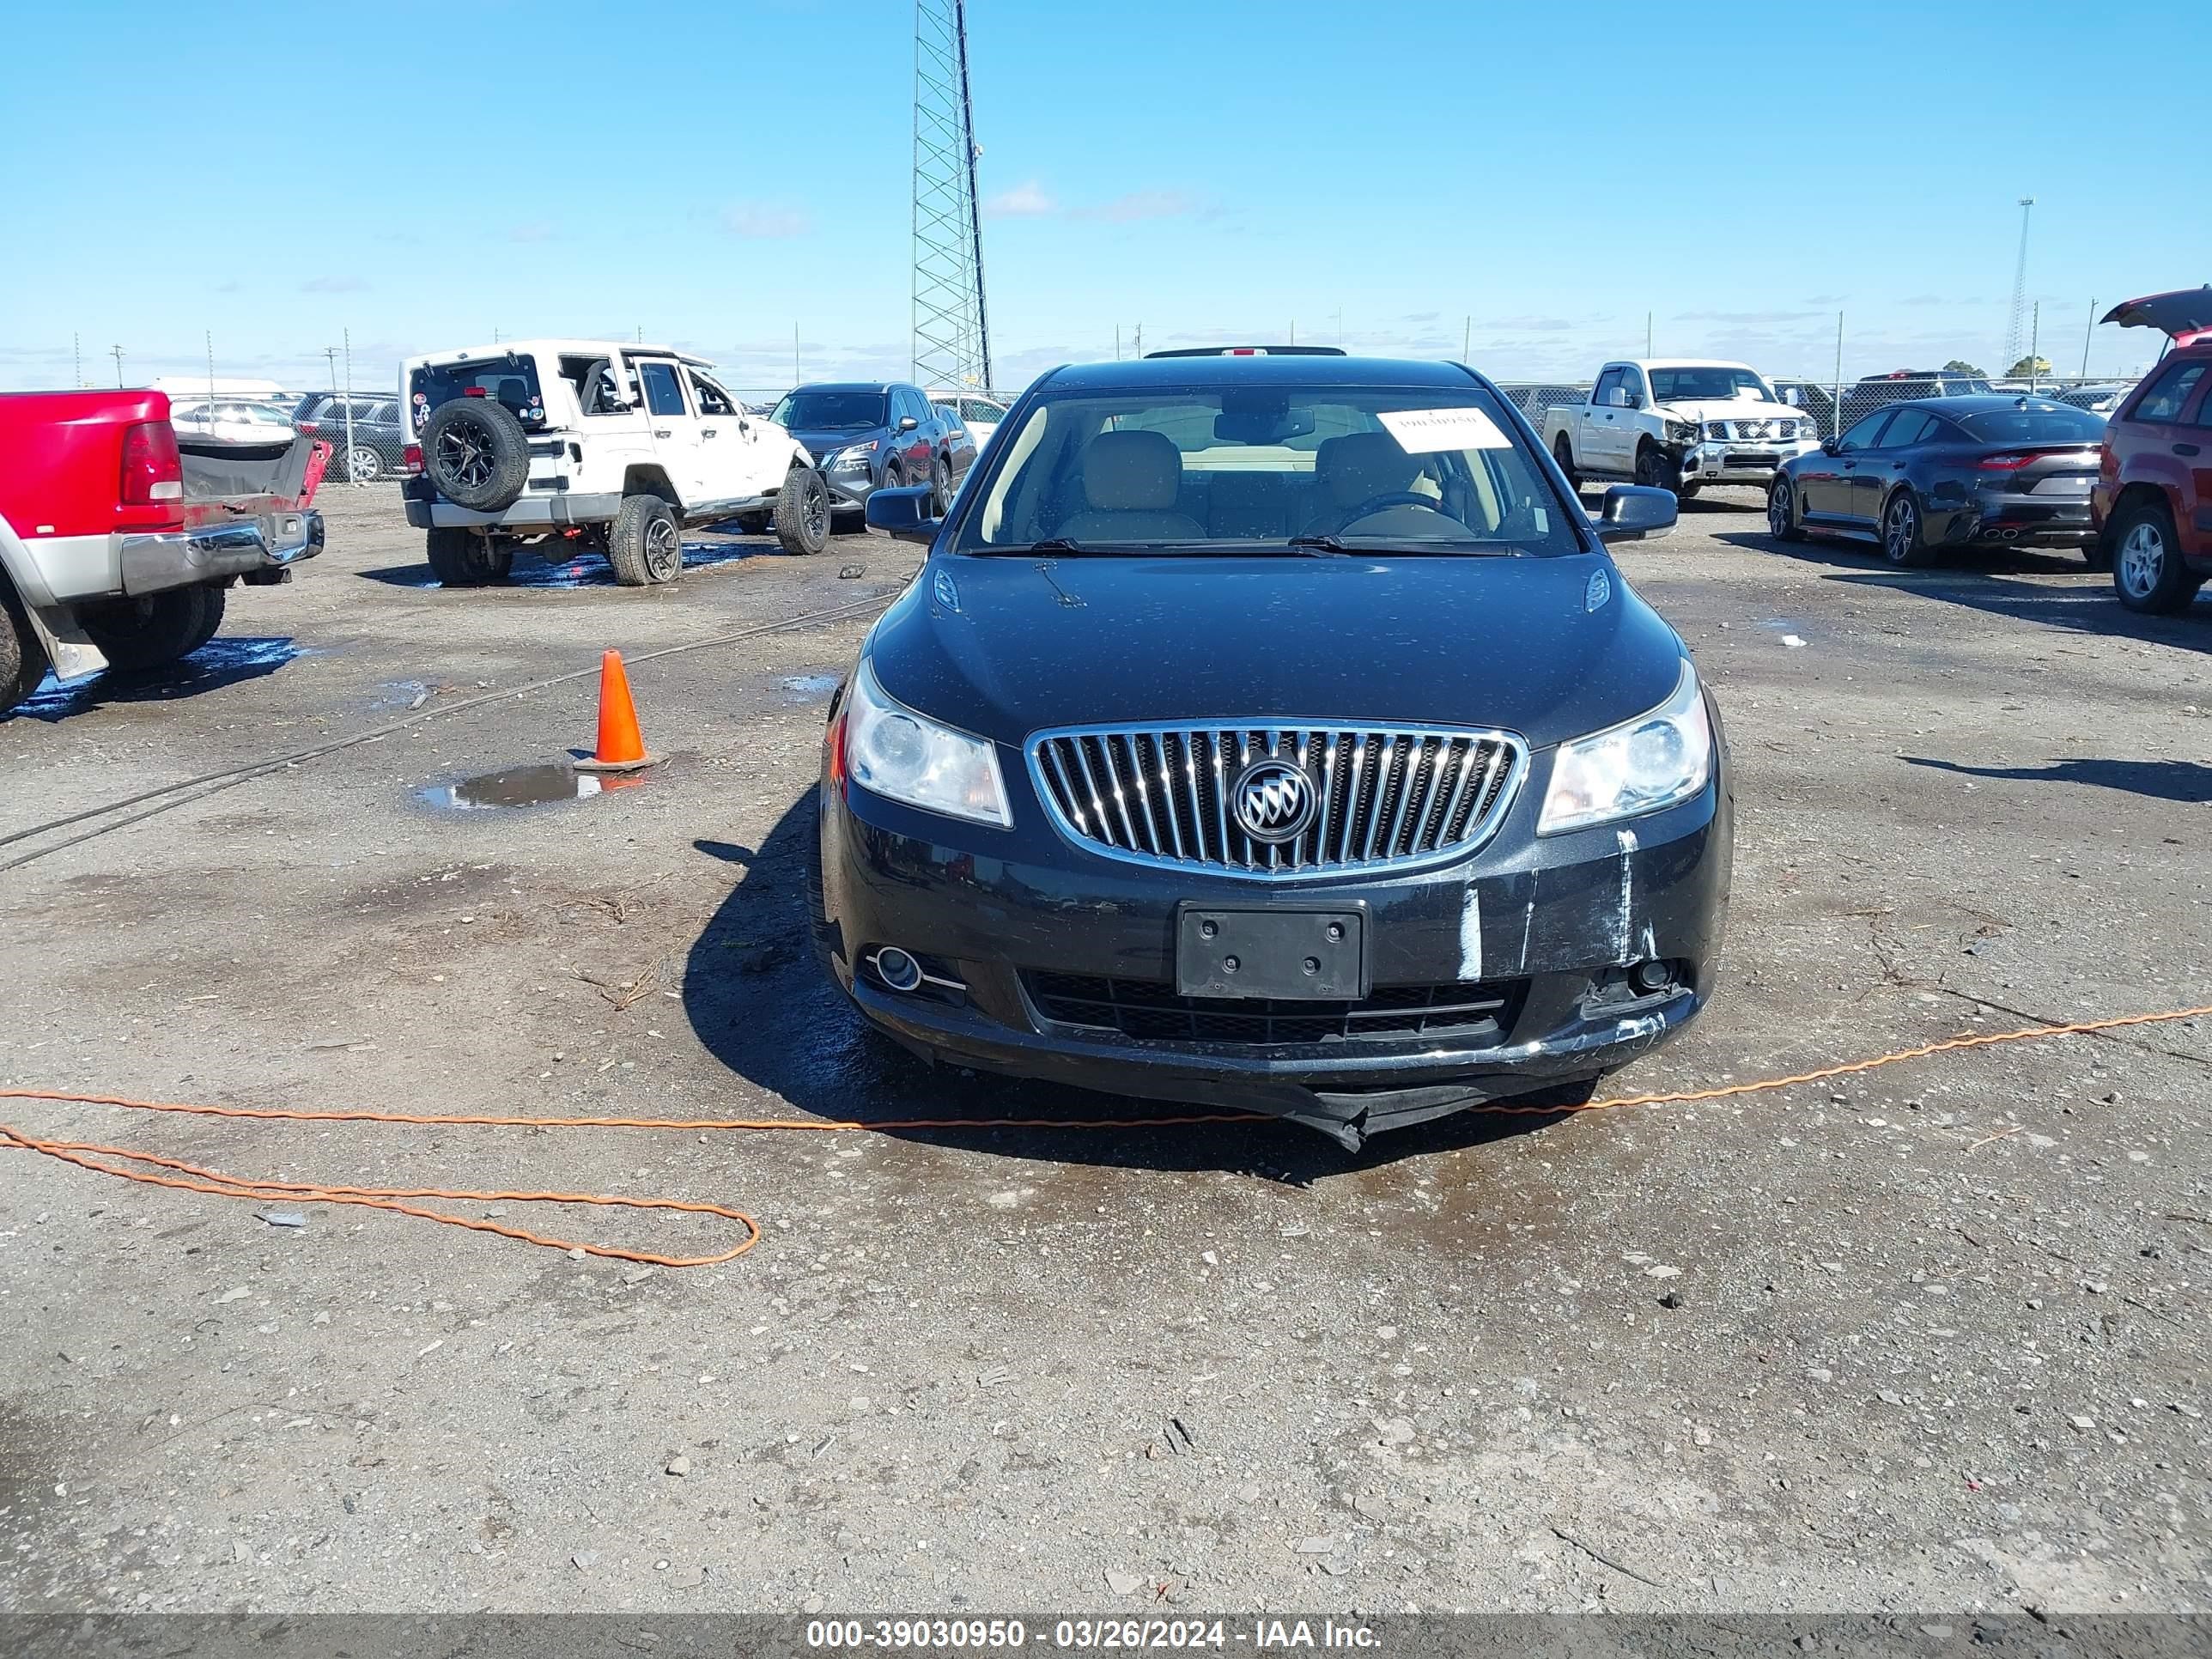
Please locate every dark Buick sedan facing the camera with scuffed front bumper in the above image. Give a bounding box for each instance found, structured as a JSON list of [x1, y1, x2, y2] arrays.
[[814, 356, 1729, 1148]]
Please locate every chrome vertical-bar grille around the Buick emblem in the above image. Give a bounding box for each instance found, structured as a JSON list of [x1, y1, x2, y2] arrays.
[[1029, 721, 1528, 878]]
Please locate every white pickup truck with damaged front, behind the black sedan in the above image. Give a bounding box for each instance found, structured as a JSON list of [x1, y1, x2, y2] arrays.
[[1544, 358, 1820, 500]]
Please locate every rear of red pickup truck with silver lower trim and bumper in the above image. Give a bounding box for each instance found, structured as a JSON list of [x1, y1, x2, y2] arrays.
[[0, 389, 330, 714]]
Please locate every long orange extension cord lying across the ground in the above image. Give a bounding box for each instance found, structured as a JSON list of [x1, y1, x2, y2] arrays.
[[0, 1005, 2212, 1267]]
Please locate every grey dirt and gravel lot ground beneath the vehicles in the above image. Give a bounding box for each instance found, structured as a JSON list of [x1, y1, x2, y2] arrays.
[[0, 491, 2212, 1613]]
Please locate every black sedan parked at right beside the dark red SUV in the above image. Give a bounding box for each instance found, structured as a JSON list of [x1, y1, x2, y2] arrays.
[[1767, 394, 2104, 564]]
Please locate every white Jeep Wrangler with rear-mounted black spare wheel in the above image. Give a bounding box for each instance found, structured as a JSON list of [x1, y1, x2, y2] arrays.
[[400, 341, 830, 588]]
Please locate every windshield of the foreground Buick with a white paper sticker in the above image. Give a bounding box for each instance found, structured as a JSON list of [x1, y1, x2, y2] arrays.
[[956, 383, 1583, 553]]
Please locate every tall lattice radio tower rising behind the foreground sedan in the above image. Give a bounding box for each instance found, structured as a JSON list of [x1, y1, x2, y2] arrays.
[[914, 0, 991, 389]]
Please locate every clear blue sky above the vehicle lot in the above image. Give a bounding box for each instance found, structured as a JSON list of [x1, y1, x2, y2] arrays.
[[0, 0, 2212, 387]]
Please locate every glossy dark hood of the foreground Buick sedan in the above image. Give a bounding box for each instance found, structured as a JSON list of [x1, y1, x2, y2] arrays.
[[867, 553, 1681, 748]]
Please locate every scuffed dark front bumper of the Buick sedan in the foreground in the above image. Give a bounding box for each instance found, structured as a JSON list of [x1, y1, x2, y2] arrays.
[[814, 750, 1732, 1148]]
